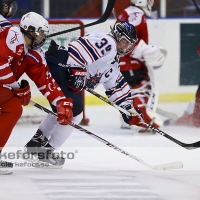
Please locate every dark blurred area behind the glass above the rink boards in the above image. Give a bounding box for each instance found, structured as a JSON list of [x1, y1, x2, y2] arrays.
[[15, 0, 200, 18]]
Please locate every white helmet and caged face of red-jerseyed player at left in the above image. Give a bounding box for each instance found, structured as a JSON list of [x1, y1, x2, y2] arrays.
[[19, 12, 49, 49]]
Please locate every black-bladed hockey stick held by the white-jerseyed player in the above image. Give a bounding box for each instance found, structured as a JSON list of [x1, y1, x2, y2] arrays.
[[84, 86, 200, 150]]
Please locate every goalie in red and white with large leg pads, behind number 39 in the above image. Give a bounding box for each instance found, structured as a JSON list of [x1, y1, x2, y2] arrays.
[[116, 0, 167, 132]]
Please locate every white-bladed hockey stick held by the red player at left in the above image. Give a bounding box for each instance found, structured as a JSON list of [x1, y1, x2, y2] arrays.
[[30, 101, 183, 170]]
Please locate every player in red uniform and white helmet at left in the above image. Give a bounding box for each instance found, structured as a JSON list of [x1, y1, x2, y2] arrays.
[[0, 12, 73, 173]]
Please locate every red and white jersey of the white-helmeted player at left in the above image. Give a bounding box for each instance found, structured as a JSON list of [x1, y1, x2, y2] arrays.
[[0, 17, 64, 105]]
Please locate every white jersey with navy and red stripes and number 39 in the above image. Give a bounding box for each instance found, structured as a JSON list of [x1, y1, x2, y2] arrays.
[[67, 31, 132, 109]]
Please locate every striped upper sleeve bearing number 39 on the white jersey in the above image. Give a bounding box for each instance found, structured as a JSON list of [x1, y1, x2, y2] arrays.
[[67, 31, 117, 67]]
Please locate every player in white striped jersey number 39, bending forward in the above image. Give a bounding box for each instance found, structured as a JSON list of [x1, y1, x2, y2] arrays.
[[25, 21, 147, 168]]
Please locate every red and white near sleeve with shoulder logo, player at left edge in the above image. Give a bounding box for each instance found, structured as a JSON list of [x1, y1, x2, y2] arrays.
[[0, 24, 25, 89]]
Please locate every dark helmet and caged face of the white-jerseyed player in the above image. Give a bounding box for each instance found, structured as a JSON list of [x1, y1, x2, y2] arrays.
[[111, 21, 137, 55]]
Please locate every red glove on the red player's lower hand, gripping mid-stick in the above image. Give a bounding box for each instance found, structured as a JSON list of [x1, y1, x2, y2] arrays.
[[56, 98, 73, 125]]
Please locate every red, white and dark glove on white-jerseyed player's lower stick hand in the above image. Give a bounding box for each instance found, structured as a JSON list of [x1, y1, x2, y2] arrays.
[[122, 108, 144, 127]]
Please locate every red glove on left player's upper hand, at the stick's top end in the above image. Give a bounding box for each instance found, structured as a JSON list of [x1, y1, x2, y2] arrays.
[[13, 80, 31, 106]]
